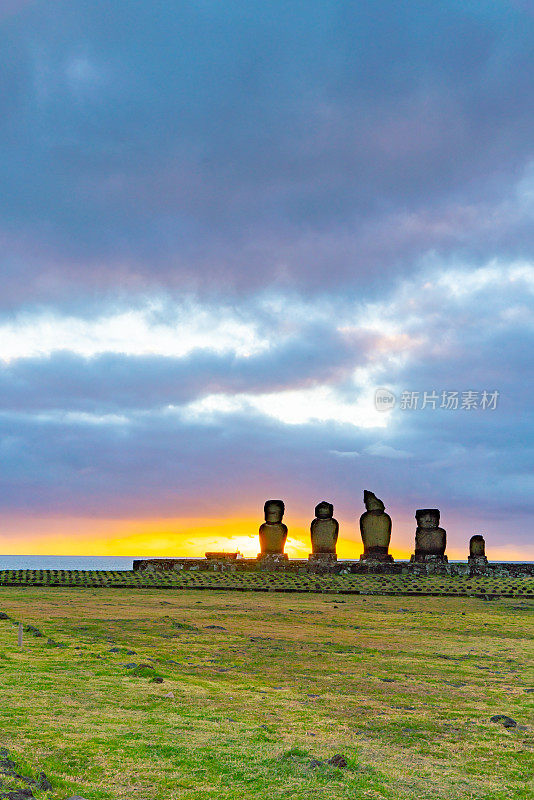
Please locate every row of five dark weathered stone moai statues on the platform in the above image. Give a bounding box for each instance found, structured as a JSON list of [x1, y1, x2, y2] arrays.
[[258, 489, 488, 566]]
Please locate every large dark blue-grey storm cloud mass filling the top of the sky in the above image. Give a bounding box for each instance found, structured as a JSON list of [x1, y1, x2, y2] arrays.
[[0, 0, 534, 303]]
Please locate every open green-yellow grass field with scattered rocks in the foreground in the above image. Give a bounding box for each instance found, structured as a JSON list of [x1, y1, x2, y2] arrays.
[[0, 587, 534, 800]]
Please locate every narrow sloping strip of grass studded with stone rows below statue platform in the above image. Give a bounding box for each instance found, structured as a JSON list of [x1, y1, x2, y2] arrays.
[[0, 570, 534, 598]]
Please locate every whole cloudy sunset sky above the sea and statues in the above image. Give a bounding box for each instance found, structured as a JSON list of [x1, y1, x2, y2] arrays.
[[0, 0, 534, 560]]
